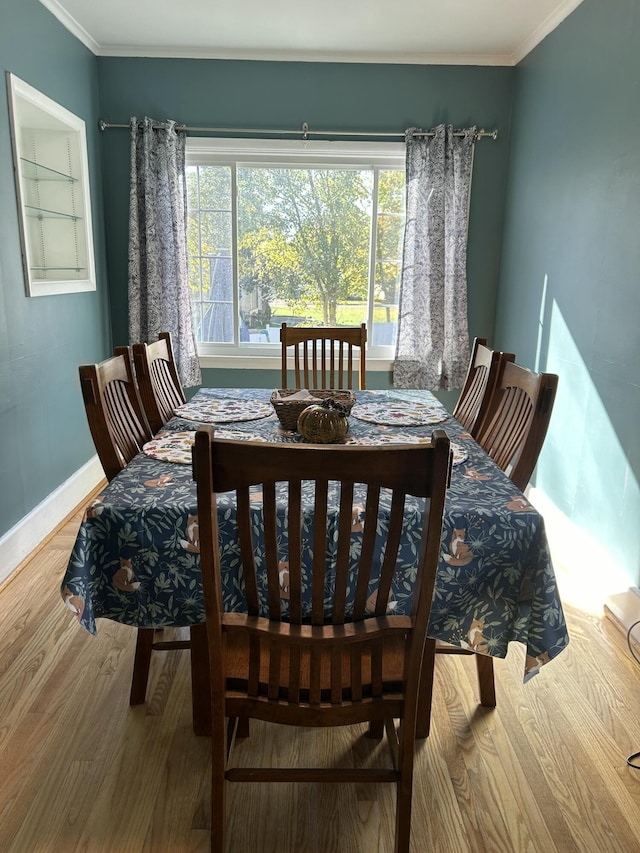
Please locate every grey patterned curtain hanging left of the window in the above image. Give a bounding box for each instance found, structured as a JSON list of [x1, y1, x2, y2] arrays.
[[129, 118, 201, 387]]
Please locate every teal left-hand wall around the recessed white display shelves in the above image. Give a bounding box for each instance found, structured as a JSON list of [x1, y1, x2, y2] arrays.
[[0, 0, 111, 536]]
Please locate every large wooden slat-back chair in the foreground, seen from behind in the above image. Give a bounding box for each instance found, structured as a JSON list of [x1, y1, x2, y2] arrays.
[[194, 427, 450, 853]]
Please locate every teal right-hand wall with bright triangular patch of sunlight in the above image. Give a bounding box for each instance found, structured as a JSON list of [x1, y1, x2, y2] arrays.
[[495, 0, 640, 584]]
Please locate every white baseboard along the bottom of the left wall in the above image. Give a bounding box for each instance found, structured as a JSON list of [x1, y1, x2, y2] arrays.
[[0, 456, 104, 584]]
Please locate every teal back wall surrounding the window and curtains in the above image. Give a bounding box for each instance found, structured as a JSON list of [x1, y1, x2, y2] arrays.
[[98, 57, 513, 372]]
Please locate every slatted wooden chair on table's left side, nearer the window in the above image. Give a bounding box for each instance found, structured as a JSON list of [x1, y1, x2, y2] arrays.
[[133, 332, 187, 434]]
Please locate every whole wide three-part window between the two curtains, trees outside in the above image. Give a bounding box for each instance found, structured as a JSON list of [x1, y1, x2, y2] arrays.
[[187, 138, 405, 357]]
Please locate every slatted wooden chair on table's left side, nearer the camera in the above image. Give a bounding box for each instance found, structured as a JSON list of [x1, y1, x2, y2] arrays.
[[80, 347, 191, 705]]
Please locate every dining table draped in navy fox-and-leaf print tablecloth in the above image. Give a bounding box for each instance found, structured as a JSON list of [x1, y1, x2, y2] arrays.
[[60, 388, 569, 734]]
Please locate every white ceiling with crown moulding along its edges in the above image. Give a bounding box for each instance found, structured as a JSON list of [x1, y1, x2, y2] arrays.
[[40, 0, 582, 65]]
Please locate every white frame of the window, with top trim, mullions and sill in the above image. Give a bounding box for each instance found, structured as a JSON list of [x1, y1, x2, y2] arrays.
[[186, 137, 406, 371]]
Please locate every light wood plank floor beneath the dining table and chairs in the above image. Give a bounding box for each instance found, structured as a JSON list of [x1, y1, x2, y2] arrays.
[[0, 502, 640, 853]]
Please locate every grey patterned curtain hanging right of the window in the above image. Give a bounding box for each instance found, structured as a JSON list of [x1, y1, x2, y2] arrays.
[[393, 125, 476, 390]]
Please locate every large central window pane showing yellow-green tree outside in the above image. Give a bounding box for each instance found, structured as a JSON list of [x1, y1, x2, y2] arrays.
[[238, 167, 373, 332]]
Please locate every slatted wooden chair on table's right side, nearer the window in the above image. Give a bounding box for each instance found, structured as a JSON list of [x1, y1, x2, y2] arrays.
[[453, 338, 516, 438]]
